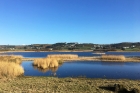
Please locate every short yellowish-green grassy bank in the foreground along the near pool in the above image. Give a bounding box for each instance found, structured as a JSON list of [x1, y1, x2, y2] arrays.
[[0, 77, 140, 93]]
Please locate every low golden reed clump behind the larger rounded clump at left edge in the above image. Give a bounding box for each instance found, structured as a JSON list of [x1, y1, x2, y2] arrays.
[[0, 55, 23, 64]]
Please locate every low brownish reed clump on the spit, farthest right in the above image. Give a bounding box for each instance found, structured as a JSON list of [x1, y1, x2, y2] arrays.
[[101, 55, 125, 61]]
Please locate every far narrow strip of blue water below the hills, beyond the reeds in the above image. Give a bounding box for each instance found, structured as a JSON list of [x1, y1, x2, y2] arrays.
[[3, 52, 140, 57]]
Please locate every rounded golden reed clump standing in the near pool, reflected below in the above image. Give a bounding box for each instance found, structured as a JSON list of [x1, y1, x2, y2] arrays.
[[33, 58, 59, 69]]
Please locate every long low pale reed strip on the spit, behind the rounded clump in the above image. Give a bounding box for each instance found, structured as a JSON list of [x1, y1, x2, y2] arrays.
[[47, 54, 78, 59]]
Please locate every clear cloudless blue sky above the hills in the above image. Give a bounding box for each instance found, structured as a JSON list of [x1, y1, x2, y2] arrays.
[[0, 0, 140, 45]]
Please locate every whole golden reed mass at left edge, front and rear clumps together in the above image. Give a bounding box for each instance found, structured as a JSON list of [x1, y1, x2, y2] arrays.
[[0, 55, 24, 78]]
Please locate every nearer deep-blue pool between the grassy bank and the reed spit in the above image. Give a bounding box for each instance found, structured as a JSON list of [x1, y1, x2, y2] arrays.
[[21, 61, 140, 79]]
